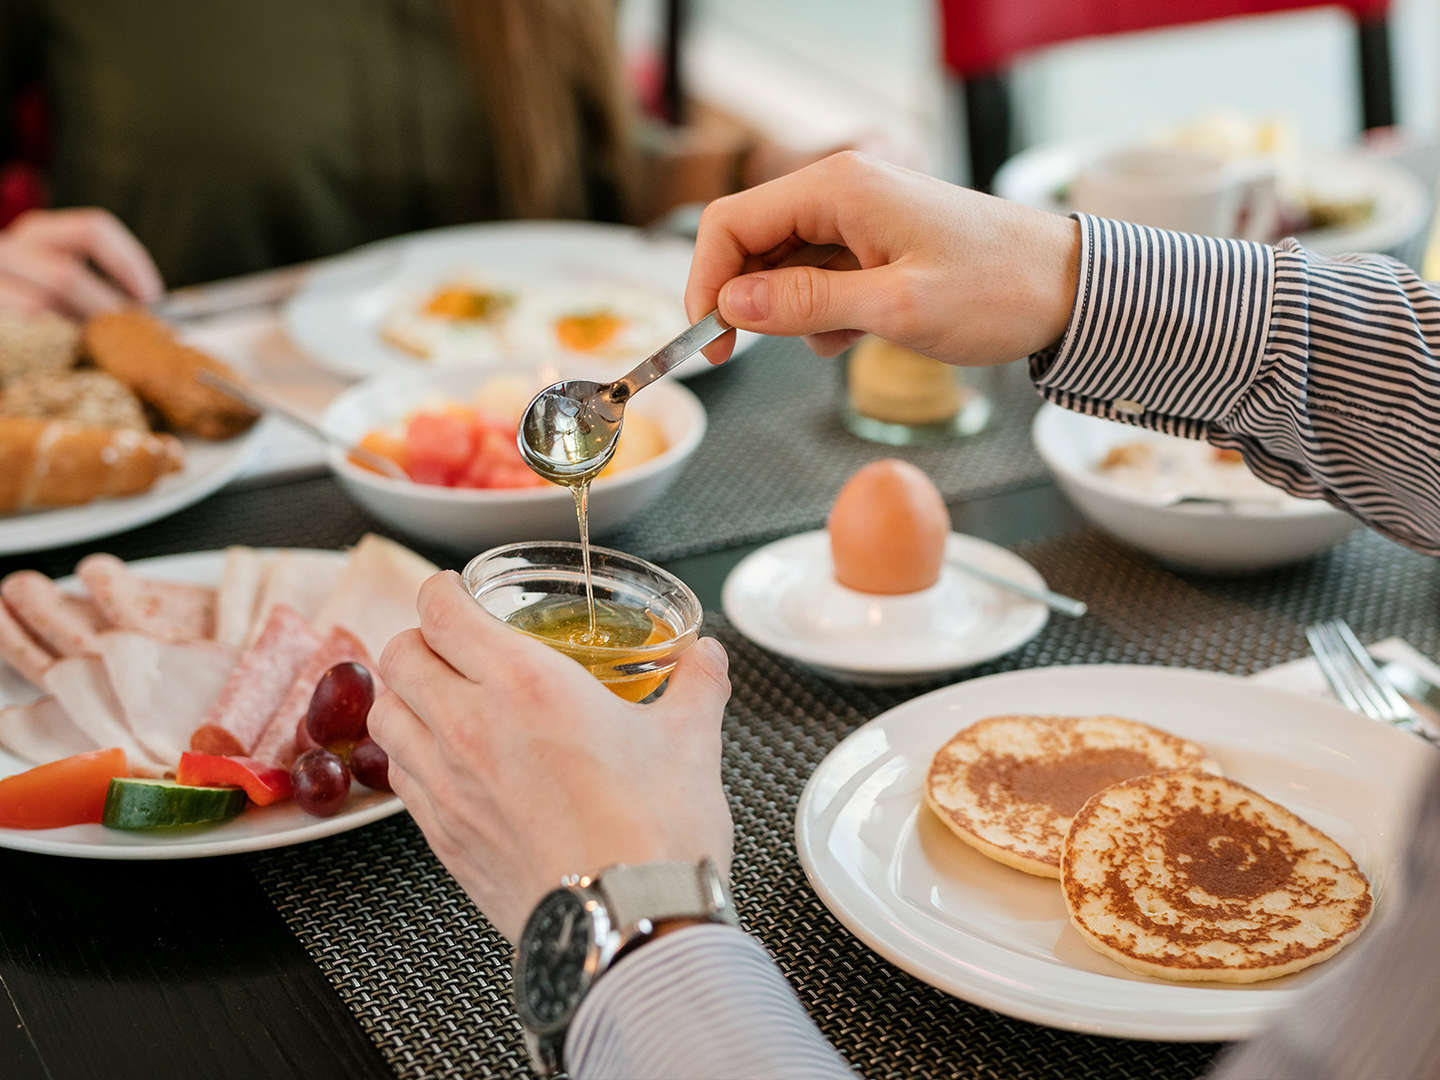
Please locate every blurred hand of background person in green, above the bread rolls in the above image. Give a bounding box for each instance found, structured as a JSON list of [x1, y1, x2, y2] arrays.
[[0, 209, 164, 318]]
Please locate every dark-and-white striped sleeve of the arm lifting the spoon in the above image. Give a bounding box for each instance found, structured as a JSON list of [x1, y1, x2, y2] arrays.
[[1031, 215, 1440, 554]]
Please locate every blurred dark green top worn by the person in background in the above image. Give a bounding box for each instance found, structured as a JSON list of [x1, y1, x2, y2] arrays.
[[0, 0, 613, 285]]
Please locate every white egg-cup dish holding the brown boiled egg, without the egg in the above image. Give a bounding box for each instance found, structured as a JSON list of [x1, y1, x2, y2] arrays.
[[720, 530, 1050, 684]]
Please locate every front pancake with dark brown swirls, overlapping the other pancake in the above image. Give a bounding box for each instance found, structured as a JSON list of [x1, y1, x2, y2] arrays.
[[1061, 770, 1374, 982]]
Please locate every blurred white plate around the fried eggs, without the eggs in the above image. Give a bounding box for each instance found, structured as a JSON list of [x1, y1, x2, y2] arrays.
[[275, 222, 759, 379]]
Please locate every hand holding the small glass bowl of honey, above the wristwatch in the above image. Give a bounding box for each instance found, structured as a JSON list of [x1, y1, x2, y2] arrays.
[[370, 572, 733, 940]]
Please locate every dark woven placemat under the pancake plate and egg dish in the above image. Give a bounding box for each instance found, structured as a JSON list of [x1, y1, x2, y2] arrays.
[[252, 533, 1440, 1080]]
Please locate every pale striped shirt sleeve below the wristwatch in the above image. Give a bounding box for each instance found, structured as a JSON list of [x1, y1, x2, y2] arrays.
[[564, 924, 854, 1080]]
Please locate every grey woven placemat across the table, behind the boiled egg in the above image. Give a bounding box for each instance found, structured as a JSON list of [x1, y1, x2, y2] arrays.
[[603, 338, 1045, 560]]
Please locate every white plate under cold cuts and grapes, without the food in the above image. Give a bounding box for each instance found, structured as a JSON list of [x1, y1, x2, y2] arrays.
[[0, 552, 405, 858]]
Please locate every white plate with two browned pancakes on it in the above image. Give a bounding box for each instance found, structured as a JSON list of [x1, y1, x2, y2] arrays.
[[795, 665, 1434, 1041]]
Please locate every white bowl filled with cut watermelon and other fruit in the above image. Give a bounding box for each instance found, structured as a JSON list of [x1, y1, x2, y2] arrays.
[[324, 361, 706, 553]]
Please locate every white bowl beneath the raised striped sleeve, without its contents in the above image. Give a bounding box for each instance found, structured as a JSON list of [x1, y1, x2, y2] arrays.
[[1031, 405, 1356, 573]]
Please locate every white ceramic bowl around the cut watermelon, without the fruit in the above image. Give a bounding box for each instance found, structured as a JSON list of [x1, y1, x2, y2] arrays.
[[324, 363, 706, 553]]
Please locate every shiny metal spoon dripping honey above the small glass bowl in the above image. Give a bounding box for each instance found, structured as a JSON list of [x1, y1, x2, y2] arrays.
[[516, 243, 841, 485]]
